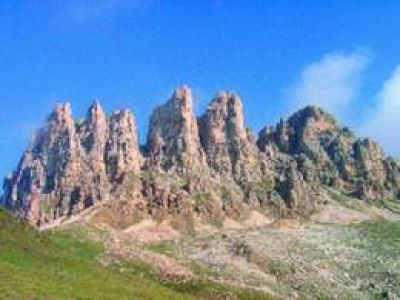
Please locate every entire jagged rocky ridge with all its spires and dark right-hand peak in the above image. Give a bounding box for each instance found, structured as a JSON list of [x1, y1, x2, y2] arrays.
[[1, 86, 400, 226]]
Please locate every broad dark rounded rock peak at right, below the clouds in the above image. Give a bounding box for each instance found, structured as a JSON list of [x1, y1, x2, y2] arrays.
[[257, 106, 399, 200]]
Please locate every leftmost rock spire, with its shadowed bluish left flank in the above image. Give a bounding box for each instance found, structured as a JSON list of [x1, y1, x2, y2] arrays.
[[4, 103, 80, 223]]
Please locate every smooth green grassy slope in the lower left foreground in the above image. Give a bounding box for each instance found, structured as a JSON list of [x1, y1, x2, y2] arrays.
[[0, 209, 268, 299]]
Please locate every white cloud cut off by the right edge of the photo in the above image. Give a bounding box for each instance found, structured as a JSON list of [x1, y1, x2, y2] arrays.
[[361, 65, 400, 157]]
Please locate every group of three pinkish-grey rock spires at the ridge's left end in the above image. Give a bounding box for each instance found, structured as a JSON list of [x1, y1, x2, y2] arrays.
[[3, 101, 140, 225]]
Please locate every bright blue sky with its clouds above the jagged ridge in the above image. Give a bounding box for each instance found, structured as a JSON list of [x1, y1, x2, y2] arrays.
[[0, 0, 400, 175]]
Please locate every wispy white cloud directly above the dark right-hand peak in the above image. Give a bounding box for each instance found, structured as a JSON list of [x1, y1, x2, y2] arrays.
[[286, 51, 371, 115]]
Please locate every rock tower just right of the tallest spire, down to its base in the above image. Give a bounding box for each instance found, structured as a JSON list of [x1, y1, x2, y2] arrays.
[[198, 91, 274, 217]]
